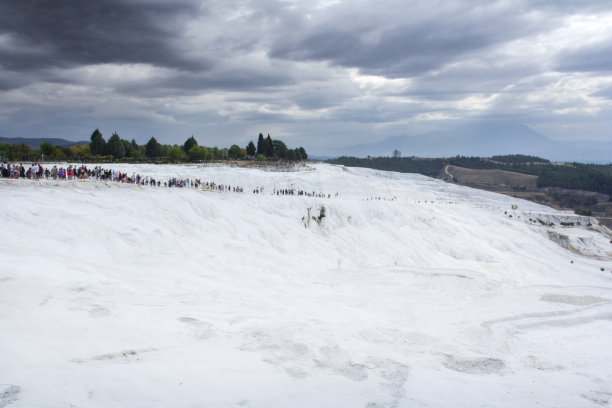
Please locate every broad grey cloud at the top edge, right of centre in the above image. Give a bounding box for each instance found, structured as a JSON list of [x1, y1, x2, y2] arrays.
[[270, 2, 550, 77]]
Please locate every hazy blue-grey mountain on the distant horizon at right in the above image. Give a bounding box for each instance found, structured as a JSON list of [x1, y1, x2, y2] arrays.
[[334, 123, 612, 163]]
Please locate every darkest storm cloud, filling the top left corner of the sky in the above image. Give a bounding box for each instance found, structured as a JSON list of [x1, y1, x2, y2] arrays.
[[0, 0, 202, 71]]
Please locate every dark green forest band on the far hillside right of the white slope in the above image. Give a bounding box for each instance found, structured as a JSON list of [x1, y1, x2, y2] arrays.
[[328, 155, 612, 200]]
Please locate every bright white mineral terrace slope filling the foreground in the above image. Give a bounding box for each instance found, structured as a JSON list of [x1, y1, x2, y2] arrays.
[[0, 165, 612, 408]]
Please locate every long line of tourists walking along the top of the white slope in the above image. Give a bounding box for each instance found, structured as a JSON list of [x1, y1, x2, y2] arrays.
[[0, 163, 338, 198]]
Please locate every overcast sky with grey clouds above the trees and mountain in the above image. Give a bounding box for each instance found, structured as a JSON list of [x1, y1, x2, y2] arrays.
[[0, 0, 612, 153]]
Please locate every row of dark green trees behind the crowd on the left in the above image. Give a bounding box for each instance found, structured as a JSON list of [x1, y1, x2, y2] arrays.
[[0, 129, 308, 163]]
